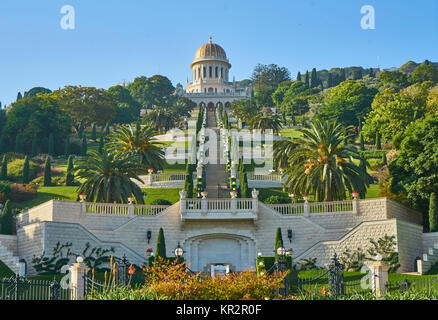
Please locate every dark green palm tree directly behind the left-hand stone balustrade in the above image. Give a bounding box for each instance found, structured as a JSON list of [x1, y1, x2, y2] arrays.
[[71, 149, 143, 203]]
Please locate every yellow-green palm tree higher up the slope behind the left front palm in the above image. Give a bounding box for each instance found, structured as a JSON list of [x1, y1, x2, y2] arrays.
[[106, 123, 164, 169]]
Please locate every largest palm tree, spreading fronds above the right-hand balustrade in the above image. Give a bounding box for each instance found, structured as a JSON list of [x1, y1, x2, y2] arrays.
[[284, 120, 372, 201]]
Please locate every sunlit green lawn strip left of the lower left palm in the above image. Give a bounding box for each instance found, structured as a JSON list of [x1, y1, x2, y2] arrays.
[[14, 187, 78, 209]]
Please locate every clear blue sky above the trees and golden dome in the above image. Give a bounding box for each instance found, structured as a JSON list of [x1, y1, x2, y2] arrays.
[[0, 0, 438, 104]]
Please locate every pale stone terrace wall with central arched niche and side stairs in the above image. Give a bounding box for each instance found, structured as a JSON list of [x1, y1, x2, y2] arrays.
[[17, 199, 428, 271]]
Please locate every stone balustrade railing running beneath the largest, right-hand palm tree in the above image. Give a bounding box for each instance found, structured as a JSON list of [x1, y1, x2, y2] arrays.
[[267, 200, 358, 215]]
